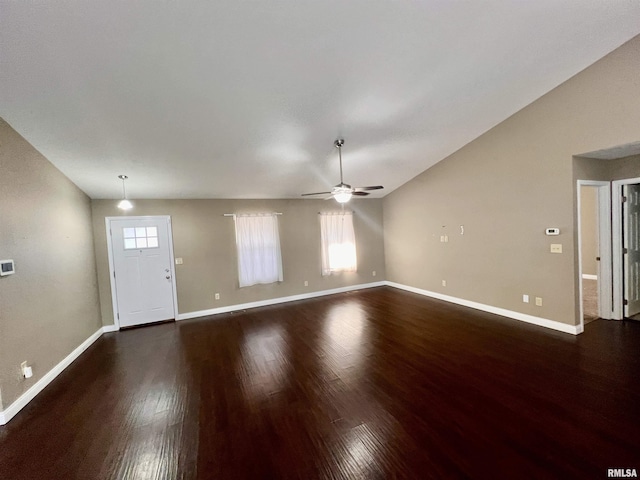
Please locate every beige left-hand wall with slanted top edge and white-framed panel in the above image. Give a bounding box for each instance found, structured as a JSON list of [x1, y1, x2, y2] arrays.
[[0, 119, 101, 408]]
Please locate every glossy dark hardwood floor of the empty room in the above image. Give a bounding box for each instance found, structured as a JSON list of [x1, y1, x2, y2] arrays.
[[0, 287, 640, 480]]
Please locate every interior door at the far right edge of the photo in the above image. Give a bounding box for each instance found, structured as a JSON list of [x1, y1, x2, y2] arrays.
[[622, 184, 640, 317]]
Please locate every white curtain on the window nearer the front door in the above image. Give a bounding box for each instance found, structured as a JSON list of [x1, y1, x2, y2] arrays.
[[235, 213, 282, 287]]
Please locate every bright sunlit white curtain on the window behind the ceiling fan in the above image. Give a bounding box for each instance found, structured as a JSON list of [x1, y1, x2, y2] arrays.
[[320, 212, 358, 275]]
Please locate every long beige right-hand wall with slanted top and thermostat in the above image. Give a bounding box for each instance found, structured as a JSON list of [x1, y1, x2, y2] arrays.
[[384, 33, 640, 325]]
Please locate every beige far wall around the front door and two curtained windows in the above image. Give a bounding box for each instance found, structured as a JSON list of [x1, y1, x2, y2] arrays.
[[92, 199, 385, 325]]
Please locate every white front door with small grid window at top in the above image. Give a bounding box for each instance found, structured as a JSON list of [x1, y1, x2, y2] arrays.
[[109, 217, 175, 327]]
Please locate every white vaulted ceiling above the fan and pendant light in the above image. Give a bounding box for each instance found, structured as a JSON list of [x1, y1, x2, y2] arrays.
[[0, 0, 640, 198]]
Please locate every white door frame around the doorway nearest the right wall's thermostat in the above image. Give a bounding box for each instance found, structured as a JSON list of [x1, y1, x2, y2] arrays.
[[576, 180, 615, 331]]
